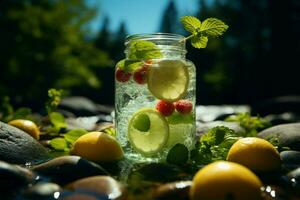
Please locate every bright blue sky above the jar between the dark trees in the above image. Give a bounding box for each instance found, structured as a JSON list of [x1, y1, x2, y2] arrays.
[[87, 0, 198, 34]]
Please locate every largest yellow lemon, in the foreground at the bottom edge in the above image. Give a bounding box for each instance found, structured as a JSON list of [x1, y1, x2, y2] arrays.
[[190, 161, 262, 200]]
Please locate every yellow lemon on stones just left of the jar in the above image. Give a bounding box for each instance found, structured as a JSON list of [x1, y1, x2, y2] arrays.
[[71, 132, 124, 162]]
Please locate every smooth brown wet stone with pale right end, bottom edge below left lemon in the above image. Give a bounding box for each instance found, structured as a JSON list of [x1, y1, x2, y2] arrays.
[[66, 176, 127, 200]]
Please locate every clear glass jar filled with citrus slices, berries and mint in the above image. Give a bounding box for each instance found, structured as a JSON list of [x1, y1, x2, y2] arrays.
[[115, 33, 196, 161]]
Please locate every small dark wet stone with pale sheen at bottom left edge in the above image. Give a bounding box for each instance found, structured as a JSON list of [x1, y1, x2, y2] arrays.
[[20, 183, 62, 200]]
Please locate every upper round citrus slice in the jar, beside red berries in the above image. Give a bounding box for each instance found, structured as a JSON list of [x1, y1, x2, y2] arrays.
[[147, 60, 189, 102]]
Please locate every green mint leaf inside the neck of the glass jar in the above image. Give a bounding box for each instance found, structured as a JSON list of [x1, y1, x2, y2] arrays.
[[128, 40, 162, 60]]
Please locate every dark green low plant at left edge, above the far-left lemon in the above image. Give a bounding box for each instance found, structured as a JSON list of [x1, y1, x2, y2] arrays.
[[0, 96, 31, 122]]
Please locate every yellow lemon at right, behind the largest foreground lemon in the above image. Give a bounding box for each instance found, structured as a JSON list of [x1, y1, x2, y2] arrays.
[[227, 137, 281, 171]]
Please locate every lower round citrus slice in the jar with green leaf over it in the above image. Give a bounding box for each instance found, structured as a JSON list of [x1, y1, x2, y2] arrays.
[[128, 108, 169, 156]]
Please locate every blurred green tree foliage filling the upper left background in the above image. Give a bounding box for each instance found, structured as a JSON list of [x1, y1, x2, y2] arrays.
[[0, 0, 111, 106]]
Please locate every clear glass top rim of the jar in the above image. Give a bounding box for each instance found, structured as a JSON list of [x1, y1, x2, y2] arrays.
[[125, 33, 185, 44]]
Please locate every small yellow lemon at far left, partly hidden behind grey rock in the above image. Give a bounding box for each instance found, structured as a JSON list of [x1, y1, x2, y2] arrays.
[[8, 119, 40, 140]]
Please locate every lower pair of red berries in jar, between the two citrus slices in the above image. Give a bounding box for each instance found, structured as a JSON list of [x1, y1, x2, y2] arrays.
[[156, 100, 193, 116]]
